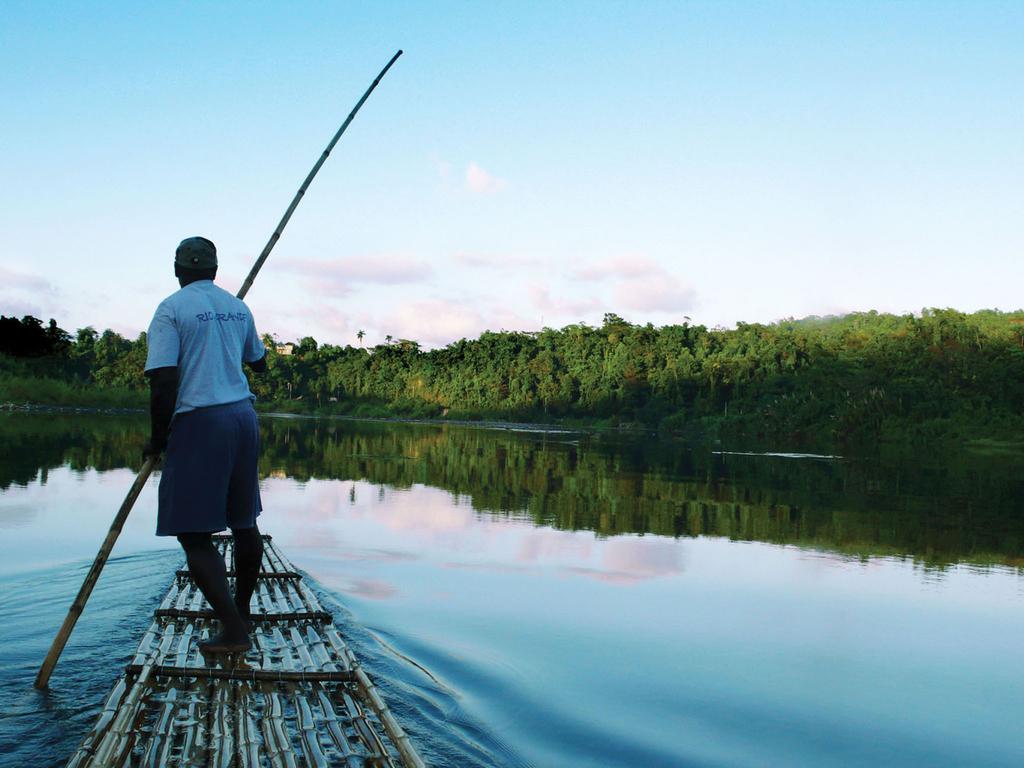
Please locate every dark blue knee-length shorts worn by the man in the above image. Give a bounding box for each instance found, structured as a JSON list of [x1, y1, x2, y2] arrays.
[[157, 399, 263, 536]]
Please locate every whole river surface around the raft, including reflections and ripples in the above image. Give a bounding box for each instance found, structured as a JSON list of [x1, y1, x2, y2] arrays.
[[0, 415, 1024, 768]]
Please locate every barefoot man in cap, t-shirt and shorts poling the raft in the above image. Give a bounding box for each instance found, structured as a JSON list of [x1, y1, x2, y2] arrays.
[[143, 238, 266, 653]]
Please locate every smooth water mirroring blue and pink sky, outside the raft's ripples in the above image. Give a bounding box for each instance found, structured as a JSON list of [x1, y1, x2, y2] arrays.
[[0, 468, 1024, 766]]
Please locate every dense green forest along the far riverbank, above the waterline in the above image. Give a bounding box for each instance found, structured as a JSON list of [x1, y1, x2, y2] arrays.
[[0, 309, 1024, 442]]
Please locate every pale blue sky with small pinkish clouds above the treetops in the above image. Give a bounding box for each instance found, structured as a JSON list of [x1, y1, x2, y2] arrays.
[[0, 2, 1024, 345]]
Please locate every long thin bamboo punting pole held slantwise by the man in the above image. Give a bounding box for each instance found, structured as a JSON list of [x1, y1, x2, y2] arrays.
[[35, 50, 402, 688]]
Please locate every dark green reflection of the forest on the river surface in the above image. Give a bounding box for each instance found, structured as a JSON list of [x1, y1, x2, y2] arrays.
[[0, 415, 1024, 566]]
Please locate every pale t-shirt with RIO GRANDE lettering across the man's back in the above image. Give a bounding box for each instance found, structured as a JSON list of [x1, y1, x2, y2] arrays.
[[145, 280, 266, 414]]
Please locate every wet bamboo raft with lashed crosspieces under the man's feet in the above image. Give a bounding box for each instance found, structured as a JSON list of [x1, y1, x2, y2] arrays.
[[68, 536, 425, 768]]
